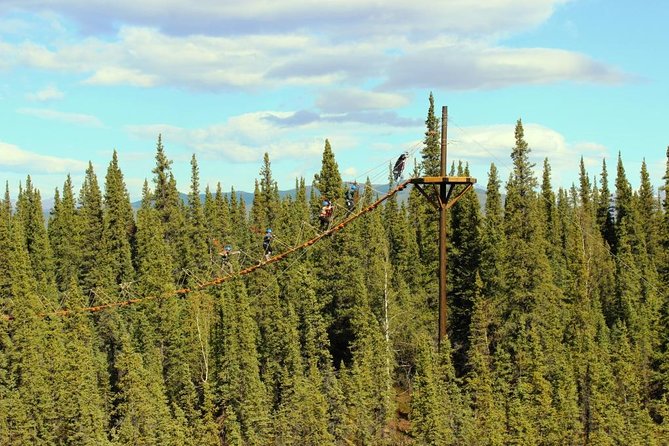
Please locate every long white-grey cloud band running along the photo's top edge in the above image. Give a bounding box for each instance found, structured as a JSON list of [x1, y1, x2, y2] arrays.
[[0, 0, 566, 40]]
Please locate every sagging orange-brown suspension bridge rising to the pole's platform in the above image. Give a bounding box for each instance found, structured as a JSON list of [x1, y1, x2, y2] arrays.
[[0, 179, 414, 321]]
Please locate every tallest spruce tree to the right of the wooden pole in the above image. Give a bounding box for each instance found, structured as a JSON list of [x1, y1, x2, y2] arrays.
[[497, 120, 563, 444]]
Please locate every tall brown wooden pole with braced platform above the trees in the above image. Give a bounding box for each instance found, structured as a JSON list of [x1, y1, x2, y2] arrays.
[[411, 106, 476, 346]]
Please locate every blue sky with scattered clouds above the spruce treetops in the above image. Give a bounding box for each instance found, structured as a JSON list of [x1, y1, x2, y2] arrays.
[[0, 0, 669, 199]]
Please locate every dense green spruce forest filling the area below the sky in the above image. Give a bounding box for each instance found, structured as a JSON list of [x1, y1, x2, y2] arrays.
[[0, 96, 669, 446]]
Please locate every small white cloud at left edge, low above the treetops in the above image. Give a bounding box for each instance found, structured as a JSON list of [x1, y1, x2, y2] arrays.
[[0, 142, 87, 174]]
